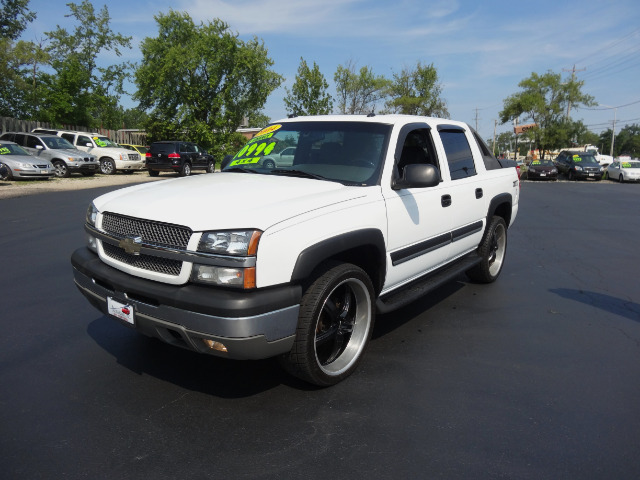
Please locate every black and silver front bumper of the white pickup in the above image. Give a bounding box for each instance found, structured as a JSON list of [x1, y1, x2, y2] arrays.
[[71, 247, 302, 359]]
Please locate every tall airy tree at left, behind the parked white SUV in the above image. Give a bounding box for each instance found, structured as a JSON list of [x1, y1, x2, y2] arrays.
[[41, 0, 131, 128]]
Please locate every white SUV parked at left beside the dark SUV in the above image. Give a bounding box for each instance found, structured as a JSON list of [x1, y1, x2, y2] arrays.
[[32, 128, 146, 175]]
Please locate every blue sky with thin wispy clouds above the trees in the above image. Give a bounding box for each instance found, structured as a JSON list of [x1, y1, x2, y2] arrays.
[[23, 0, 640, 138]]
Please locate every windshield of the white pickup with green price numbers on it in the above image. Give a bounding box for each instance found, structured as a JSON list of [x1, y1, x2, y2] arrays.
[[224, 121, 391, 186]]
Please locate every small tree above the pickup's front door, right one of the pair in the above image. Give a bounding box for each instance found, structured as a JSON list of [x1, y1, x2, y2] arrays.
[[385, 62, 449, 118]]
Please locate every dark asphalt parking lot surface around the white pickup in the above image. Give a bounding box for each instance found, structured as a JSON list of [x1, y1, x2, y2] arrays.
[[0, 182, 640, 480]]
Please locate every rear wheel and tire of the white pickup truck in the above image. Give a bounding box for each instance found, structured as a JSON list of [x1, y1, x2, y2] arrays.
[[467, 216, 507, 283]]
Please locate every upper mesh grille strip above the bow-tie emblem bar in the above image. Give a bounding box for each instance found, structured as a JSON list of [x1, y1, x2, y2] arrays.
[[102, 213, 193, 249]]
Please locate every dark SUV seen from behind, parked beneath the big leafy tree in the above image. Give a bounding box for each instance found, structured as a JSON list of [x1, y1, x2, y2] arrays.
[[147, 141, 216, 177]]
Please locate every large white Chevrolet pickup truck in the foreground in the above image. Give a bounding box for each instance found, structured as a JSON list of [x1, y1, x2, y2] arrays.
[[71, 115, 520, 386]]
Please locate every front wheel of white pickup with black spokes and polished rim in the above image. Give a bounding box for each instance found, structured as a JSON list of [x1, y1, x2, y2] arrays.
[[280, 262, 375, 387]]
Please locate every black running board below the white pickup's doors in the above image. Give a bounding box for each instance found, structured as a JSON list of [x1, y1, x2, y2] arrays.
[[376, 252, 482, 313]]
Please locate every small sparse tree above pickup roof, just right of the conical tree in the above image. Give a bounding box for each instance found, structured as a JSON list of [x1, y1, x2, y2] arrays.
[[333, 60, 390, 115]]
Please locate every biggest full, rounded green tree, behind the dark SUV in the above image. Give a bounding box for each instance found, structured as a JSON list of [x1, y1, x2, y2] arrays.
[[134, 10, 282, 154]]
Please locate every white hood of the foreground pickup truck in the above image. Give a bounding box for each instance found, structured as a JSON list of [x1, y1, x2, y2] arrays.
[[94, 173, 370, 231]]
